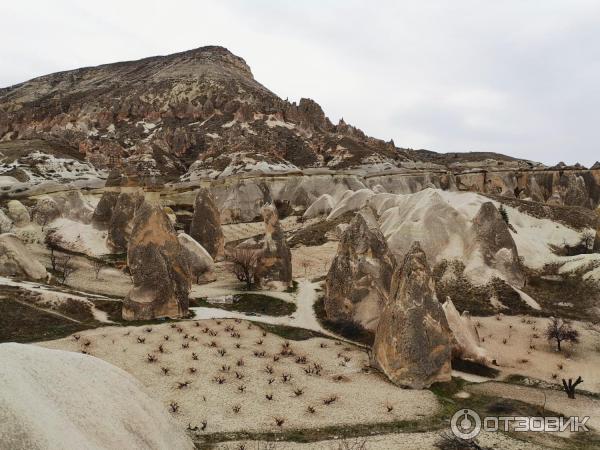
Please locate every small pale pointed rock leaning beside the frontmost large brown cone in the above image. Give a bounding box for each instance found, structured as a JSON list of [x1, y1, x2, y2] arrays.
[[442, 298, 490, 364]]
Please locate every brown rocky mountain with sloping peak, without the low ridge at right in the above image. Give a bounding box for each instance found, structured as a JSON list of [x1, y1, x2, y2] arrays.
[[0, 46, 408, 178]]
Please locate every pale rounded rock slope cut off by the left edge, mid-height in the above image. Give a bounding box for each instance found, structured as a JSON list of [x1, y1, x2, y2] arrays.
[[0, 233, 48, 280]]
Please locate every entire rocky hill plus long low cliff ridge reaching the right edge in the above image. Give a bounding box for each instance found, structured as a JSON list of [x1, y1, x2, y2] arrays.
[[0, 46, 600, 211]]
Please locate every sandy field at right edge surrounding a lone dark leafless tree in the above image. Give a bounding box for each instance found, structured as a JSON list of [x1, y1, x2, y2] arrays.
[[473, 316, 600, 392]]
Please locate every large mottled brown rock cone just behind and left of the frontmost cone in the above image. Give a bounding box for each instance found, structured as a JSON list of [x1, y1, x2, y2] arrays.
[[325, 208, 395, 331]]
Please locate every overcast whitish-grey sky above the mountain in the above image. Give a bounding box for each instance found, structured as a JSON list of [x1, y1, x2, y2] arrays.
[[0, 0, 600, 166]]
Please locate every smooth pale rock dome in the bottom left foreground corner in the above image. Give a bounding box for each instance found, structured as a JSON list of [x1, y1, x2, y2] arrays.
[[0, 343, 194, 450]]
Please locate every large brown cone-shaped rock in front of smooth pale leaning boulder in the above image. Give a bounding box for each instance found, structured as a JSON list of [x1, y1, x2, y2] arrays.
[[123, 203, 191, 320]]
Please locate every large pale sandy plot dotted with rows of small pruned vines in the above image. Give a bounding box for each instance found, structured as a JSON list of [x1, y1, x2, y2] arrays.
[[40, 320, 438, 433]]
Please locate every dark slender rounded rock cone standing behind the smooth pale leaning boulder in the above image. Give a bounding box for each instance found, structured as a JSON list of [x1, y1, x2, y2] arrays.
[[190, 188, 225, 259]]
